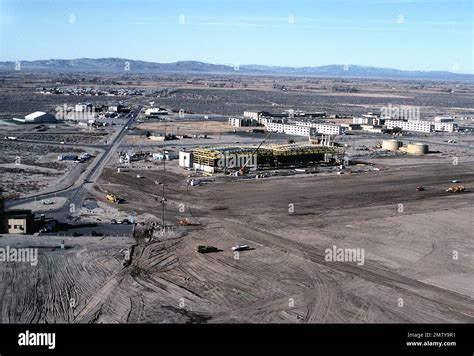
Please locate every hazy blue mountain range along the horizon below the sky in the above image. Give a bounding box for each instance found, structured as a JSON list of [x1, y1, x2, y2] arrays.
[[0, 58, 474, 81]]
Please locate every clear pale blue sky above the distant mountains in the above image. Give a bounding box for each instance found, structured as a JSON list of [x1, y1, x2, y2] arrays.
[[0, 0, 474, 74]]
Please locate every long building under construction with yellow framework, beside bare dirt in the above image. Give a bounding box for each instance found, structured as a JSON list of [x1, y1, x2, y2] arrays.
[[193, 143, 343, 172]]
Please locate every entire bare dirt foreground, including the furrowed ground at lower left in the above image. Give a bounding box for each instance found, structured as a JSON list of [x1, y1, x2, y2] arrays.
[[1, 160, 474, 323]]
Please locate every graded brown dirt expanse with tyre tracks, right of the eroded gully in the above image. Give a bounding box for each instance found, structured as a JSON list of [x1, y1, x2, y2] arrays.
[[93, 160, 474, 323]]
